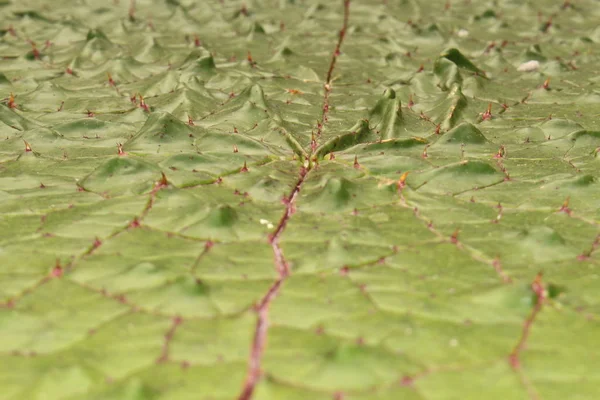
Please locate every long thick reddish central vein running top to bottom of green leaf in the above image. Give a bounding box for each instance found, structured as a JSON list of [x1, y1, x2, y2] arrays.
[[238, 0, 350, 400]]
